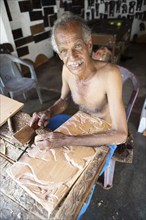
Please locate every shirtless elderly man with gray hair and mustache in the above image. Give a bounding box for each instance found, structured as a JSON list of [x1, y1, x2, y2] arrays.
[[31, 13, 128, 153]]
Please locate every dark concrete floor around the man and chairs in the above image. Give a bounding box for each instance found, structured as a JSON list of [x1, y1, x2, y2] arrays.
[[23, 43, 146, 220]]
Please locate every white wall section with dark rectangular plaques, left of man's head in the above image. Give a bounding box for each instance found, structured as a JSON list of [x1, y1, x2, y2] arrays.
[[1, 0, 56, 63]]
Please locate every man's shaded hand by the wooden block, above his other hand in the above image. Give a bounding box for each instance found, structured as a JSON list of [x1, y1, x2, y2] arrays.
[[30, 110, 51, 128]]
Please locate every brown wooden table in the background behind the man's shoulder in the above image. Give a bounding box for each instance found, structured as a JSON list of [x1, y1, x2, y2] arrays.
[[88, 18, 133, 63]]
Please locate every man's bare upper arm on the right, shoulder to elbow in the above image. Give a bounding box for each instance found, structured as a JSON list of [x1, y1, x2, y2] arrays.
[[107, 66, 128, 144]]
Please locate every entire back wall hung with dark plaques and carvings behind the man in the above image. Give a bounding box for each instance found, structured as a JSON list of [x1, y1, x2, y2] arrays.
[[0, 0, 146, 62]]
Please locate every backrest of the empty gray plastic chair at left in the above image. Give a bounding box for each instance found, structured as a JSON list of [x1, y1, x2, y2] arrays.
[[0, 54, 22, 83]]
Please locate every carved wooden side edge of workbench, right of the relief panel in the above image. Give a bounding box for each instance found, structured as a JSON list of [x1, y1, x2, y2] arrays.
[[51, 146, 107, 220]]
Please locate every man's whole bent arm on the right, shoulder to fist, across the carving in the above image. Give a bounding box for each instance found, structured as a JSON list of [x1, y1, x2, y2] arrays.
[[35, 65, 128, 147]]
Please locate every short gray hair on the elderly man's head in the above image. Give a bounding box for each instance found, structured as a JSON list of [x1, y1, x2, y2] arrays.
[[51, 12, 91, 54]]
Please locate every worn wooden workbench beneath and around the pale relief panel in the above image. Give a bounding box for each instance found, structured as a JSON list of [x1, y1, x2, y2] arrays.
[[0, 112, 109, 220]]
